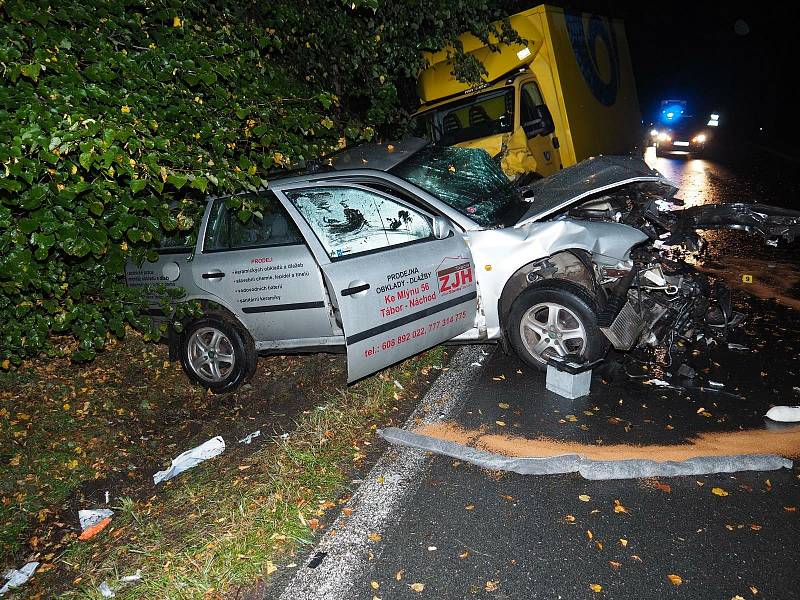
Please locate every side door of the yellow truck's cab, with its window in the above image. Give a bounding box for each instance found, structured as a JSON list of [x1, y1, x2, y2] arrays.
[[519, 81, 561, 177]]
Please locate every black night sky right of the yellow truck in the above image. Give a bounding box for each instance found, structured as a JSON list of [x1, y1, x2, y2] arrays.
[[509, 0, 800, 147]]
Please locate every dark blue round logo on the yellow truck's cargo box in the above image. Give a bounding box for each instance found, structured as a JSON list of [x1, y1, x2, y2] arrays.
[[564, 11, 619, 106]]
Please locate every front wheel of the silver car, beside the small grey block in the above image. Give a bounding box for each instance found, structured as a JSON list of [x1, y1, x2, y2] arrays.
[[506, 280, 609, 371]]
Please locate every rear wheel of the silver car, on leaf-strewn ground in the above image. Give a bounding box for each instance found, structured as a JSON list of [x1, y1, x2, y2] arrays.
[[178, 313, 258, 394]]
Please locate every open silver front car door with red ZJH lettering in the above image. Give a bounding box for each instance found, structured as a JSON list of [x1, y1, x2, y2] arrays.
[[277, 182, 477, 381]]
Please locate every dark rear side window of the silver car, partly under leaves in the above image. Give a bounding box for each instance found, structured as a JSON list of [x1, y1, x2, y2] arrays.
[[203, 192, 304, 251]]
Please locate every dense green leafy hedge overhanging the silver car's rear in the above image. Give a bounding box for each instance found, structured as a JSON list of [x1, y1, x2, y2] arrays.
[[0, 0, 520, 369]]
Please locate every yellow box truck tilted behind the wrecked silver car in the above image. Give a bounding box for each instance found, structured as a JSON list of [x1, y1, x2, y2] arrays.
[[411, 5, 641, 179]]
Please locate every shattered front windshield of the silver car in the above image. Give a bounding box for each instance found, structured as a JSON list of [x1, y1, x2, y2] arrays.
[[391, 146, 528, 227]]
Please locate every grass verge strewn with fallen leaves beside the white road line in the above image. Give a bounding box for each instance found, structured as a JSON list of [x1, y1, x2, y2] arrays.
[[0, 330, 443, 598]]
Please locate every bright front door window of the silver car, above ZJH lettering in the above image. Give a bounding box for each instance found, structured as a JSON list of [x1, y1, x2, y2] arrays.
[[286, 187, 433, 258]]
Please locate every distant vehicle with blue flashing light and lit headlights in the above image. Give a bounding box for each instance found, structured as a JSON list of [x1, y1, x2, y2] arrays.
[[650, 100, 719, 158]]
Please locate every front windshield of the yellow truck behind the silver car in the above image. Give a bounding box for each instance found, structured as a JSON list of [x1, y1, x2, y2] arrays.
[[411, 87, 514, 145]]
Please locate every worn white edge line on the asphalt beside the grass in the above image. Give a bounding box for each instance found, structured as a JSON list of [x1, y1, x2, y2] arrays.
[[280, 346, 482, 600]]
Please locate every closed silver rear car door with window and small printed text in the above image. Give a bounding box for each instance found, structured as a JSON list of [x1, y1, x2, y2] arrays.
[[192, 192, 333, 348]]
